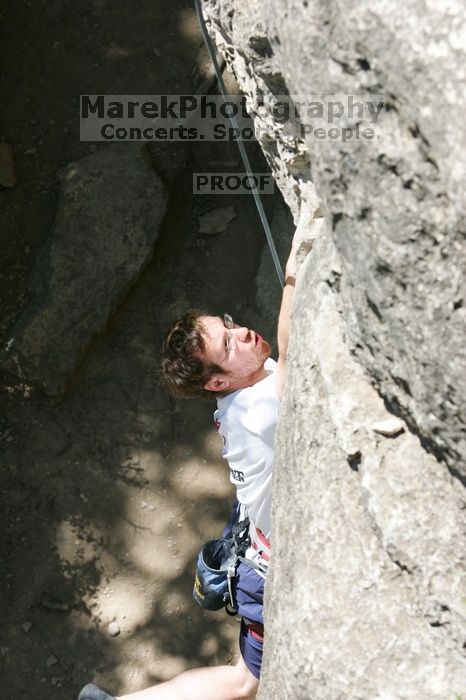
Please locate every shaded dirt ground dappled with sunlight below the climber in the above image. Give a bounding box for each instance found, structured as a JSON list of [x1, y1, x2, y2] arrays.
[[0, 0, 290, 700]]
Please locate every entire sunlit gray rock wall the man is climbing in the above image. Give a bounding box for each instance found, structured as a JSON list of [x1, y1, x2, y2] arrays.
[[204, 0, 466, 700]]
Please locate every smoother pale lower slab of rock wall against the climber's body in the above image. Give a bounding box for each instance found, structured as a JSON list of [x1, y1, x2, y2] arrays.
[[268, 227, 466, 700]]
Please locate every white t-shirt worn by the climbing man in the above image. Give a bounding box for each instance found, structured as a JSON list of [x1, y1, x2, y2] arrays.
[[214, 358, 280, 568]]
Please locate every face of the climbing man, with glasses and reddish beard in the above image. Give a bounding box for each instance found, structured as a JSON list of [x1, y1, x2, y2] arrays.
[[198, 314, 271, 393]]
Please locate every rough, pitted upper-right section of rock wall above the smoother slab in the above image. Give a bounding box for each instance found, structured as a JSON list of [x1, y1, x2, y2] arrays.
[[204, 0, 466, 475]]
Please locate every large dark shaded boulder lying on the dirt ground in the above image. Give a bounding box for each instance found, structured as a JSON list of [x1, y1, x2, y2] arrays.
[[1, 144, 167, 394]]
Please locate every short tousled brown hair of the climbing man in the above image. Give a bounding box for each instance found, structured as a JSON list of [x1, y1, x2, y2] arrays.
[[160, 309, 225, 399]]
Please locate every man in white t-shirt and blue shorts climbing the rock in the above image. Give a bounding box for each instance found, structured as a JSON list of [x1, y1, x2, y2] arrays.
[[78, 189, 314, 700]]
